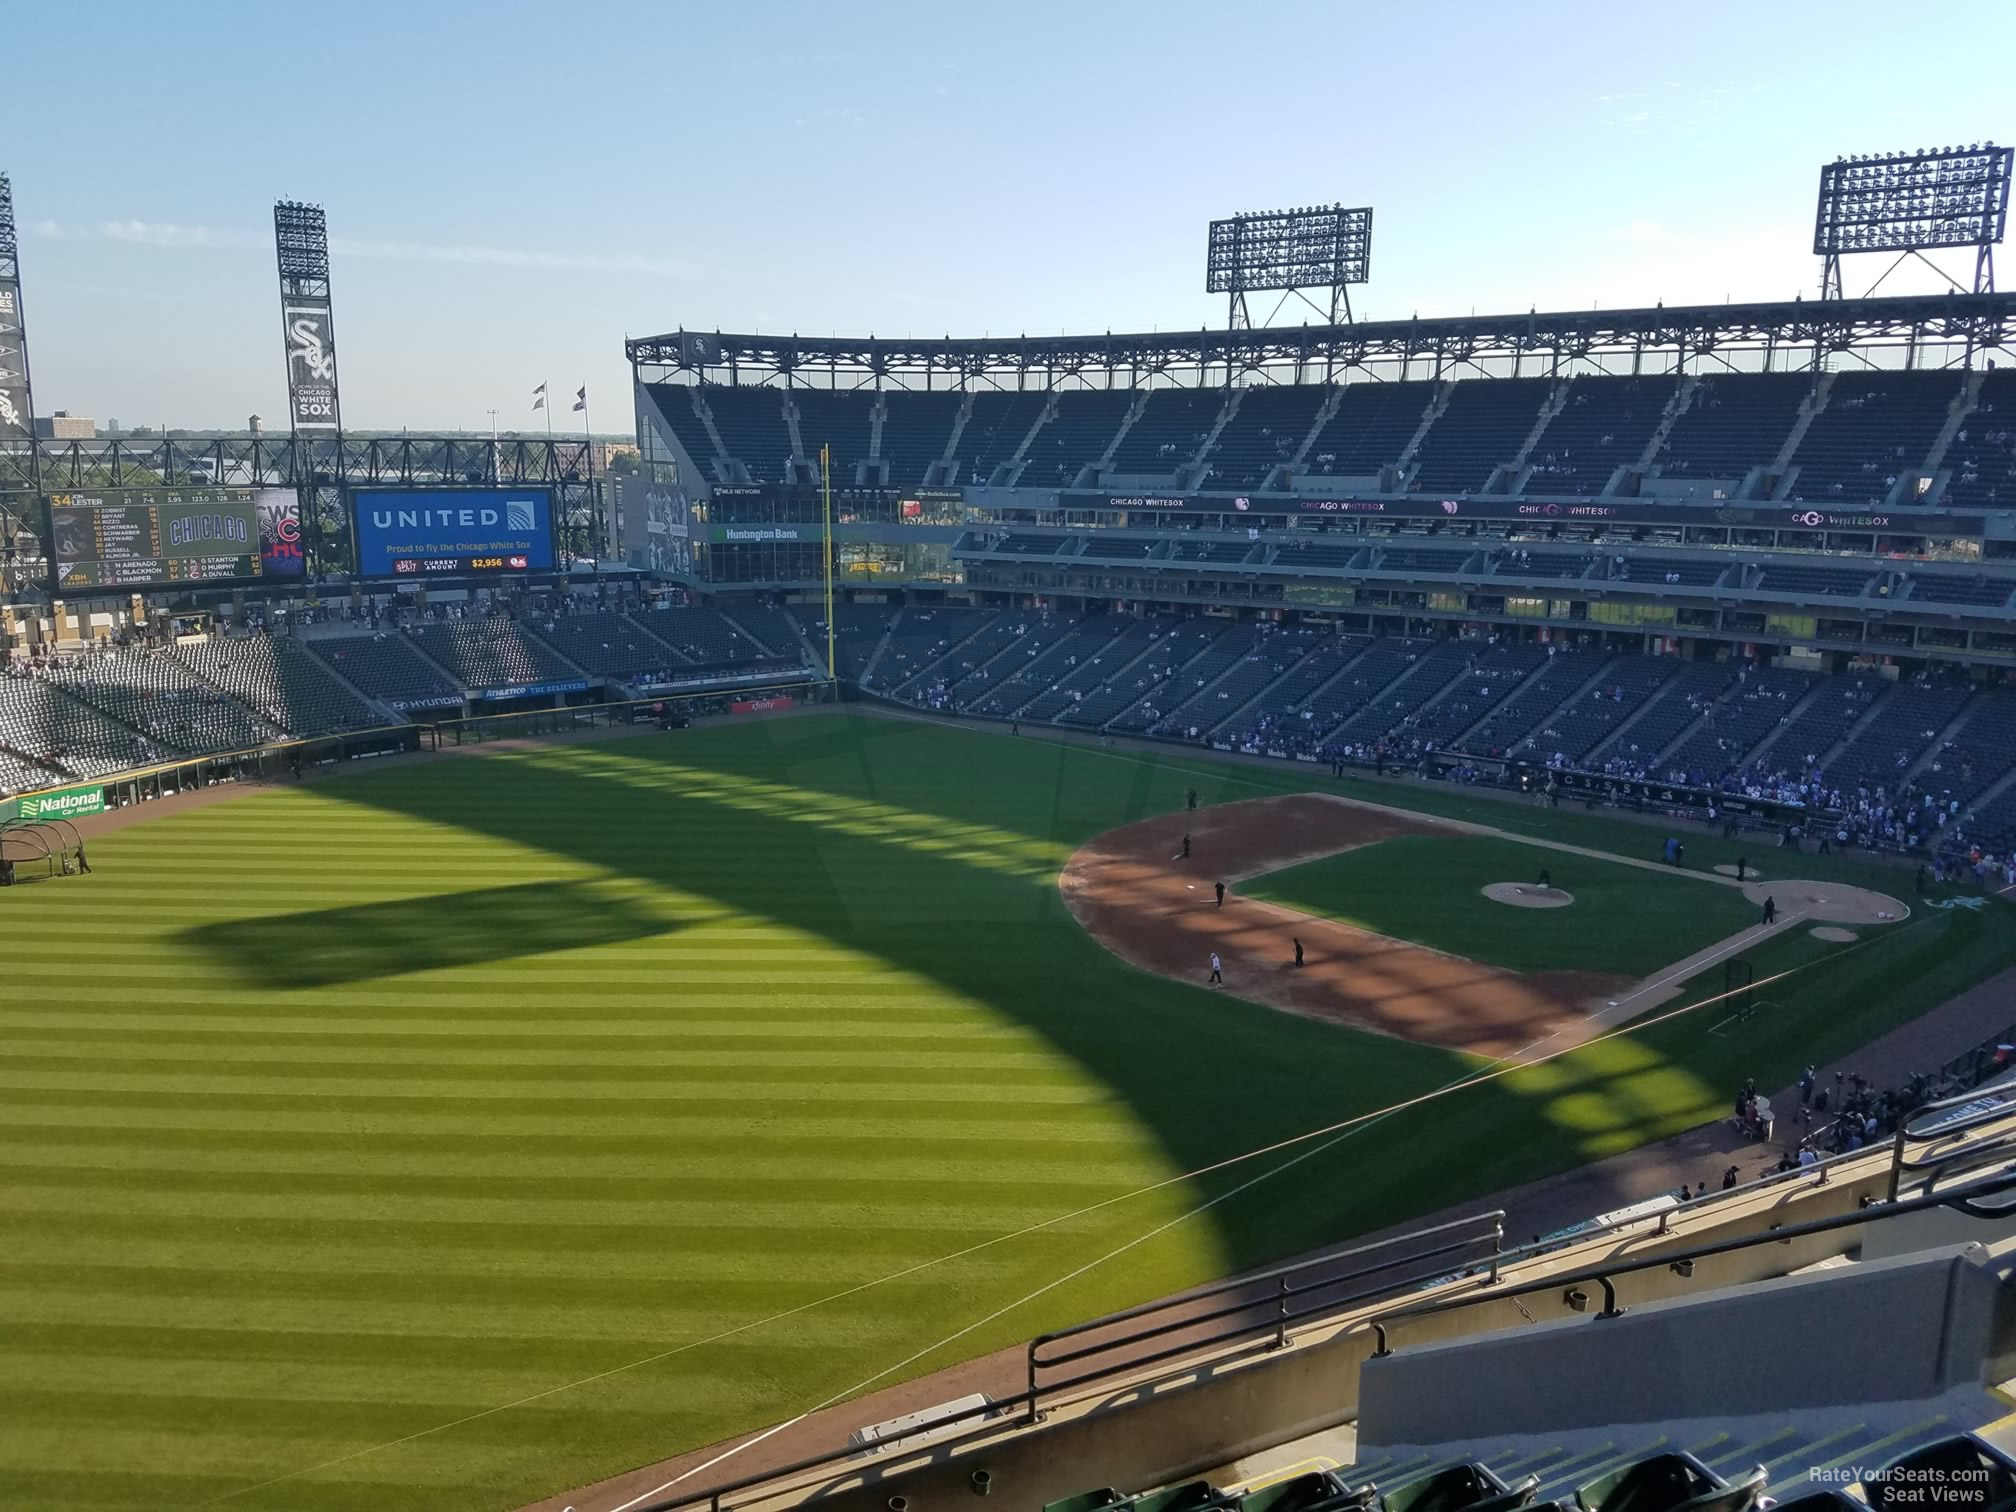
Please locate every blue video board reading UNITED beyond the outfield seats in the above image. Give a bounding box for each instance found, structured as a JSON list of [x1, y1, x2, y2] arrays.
[[351, 488, 554, 577]]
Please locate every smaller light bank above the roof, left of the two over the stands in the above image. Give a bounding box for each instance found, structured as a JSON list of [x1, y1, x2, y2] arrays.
[[1204, 206, 1373, 331]]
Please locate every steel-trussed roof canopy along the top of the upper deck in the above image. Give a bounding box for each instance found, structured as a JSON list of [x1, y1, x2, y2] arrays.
[[625, 292, 2016, 389]]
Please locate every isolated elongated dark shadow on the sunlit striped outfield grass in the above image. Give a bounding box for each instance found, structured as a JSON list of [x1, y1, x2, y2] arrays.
[[177, 881, 675, 988]]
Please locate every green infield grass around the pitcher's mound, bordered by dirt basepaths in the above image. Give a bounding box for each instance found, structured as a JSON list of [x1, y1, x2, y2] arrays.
[[1240, 835, 1758, 978]]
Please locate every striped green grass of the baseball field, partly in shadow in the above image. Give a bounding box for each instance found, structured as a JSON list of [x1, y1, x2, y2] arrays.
[[0, 712, 2016, 1512]]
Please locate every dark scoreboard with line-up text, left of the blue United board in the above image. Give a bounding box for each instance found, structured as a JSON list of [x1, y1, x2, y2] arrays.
[[48, 488, 302, 593]]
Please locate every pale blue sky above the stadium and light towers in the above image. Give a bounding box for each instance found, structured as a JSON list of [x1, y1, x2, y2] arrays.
[[0, 0, 2016, 431]]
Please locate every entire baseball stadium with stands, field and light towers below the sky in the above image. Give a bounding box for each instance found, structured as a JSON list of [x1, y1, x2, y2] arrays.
[[0, 145, 2016, 1512]]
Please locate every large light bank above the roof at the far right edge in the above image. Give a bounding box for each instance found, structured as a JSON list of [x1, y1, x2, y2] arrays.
[[1812, 141, 2016, 298]]
